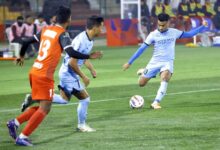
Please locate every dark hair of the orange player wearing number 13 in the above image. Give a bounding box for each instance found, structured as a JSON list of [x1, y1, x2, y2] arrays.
[[56, 6, 71, 24]]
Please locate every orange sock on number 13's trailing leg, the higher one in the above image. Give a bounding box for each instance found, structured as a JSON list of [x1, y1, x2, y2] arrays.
[[16, 106, 39, 124]]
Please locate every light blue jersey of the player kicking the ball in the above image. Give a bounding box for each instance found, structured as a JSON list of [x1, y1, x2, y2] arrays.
[[145, 28, 183, 62]]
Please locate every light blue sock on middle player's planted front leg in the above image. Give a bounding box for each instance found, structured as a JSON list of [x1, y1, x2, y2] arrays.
[[77, 97, 90, 125]]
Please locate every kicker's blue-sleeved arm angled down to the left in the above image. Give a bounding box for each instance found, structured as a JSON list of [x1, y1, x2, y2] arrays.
[[123, 43, 149, 70]]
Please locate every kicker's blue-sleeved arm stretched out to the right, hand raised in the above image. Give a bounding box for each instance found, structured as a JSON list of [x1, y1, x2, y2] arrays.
[[179, 21, 208, 38]]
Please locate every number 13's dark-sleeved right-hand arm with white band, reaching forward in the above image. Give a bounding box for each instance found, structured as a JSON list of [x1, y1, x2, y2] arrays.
[[59, 32, 102, 59]]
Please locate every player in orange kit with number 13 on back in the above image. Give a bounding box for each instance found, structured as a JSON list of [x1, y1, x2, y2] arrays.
[[7, 6, 102, 146]]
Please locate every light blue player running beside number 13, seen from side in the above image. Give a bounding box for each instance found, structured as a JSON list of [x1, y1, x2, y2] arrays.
[[22, 16, 104, 132]]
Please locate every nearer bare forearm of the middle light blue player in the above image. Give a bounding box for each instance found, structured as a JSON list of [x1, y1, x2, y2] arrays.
[[69, 58, 90, 86]]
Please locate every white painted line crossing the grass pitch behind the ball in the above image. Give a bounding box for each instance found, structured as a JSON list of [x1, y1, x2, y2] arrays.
[[0, 88, 220, 113]]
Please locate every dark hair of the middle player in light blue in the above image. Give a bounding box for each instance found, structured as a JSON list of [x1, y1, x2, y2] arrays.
[[86, 16, 104, 30]]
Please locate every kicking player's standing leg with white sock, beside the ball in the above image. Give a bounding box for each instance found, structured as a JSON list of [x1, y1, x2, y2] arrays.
[[151, 62, 173, 109]]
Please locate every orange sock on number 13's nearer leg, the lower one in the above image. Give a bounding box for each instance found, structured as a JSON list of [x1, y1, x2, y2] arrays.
[[21, 108, 47, 136]]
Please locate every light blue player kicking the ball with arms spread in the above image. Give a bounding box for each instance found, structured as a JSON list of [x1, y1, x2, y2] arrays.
[[123, 13, 208, 109]]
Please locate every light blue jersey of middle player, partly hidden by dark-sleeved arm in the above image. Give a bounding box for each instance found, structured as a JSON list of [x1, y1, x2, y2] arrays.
[[59, 31, 93, 80]]
